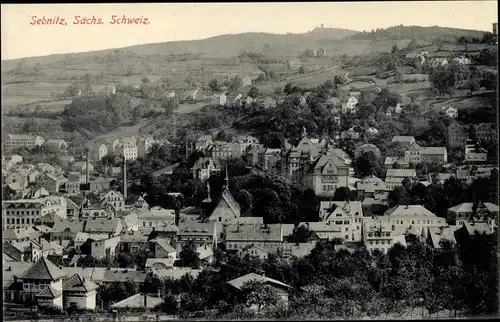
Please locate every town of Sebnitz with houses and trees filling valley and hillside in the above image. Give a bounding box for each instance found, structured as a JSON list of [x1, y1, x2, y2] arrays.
[[2, 8, 498, 321]]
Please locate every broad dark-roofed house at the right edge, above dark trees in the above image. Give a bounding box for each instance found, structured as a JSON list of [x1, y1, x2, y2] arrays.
[[447, 201, 498, 227]]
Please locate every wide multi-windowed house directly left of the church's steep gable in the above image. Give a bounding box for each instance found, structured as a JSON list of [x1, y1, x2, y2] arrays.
[[176, 222, 222, 252]]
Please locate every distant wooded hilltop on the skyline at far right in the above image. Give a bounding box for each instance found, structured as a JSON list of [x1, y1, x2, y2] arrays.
[[348, 25, 486, 42]]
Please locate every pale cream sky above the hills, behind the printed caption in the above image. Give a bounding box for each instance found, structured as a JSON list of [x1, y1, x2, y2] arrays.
[[1, 0, 497, 60]]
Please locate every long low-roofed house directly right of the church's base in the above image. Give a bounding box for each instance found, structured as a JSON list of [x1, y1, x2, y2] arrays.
[[225, 224, 283, 253]]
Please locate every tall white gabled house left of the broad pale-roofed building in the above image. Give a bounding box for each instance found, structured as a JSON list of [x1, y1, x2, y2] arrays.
[[320, 201, 363, 242]]
